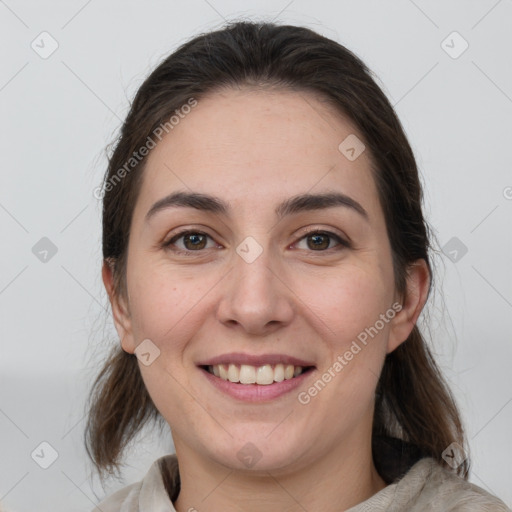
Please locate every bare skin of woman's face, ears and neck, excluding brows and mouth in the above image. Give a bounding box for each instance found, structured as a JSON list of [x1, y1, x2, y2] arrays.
[[103, 89, 429, 512]]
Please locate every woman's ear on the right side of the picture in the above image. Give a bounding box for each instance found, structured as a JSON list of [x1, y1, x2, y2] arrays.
[[386, 259, 430, 354]]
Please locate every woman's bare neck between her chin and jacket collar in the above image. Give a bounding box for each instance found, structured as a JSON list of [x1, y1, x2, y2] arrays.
[[174, 430, 386, 512]]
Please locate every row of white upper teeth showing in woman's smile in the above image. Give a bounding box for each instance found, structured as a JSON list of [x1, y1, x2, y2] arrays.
[[208, 363, 303, 386]]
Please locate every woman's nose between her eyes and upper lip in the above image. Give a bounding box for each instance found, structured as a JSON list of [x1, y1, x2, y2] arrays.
[[217, 243, 294, 336]]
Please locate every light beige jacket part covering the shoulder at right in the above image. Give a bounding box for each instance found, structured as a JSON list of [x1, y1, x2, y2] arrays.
[[395, 457, 510, 512]]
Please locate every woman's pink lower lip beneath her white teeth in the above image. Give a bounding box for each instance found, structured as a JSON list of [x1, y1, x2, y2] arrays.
[[199, 368, 314, 402]]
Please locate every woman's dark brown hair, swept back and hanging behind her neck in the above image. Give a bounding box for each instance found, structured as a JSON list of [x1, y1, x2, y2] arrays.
[[86, 21, 469, 478]]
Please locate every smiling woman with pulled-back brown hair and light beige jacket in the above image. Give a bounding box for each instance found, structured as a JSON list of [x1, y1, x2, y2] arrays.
[[87, 22, 508, 512]]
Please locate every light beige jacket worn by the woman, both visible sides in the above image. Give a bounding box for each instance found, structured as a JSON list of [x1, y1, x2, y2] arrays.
[[93, 455, 511, 512]]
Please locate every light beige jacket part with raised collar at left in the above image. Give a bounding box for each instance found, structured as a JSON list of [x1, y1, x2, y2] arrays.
[[92, 455, 177, 512]]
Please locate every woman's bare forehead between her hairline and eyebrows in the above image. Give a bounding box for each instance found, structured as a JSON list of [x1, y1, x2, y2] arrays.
[[134, 89, 377, 222]]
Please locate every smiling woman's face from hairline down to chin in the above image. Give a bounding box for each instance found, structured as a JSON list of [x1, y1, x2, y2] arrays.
[[104, 90, 415, 470]]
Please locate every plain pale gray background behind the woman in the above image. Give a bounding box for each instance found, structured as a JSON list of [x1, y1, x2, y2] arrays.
[[0, 0, 512, 512]]
